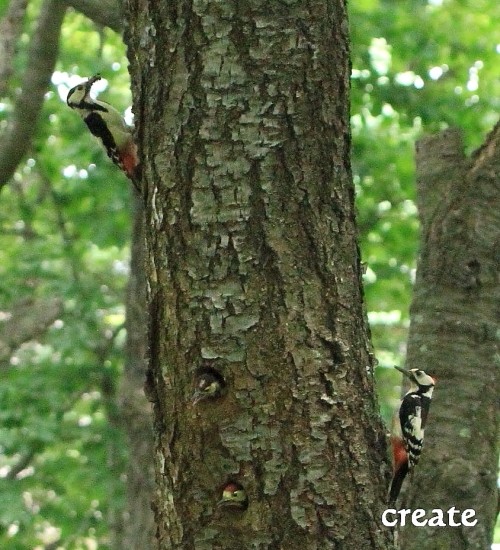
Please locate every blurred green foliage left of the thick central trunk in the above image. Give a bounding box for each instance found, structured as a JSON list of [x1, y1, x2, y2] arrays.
[[0, 4, 131, 550]]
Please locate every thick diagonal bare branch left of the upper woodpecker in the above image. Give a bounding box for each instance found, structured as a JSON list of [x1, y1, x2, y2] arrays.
[[0, 0, 66, 189]]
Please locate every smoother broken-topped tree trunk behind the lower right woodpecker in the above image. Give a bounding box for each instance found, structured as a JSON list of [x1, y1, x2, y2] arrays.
[[401, 124, 500, 550]]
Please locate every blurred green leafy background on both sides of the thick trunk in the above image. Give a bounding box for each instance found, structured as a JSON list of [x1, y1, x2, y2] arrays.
[[0, 0, 500, 550]]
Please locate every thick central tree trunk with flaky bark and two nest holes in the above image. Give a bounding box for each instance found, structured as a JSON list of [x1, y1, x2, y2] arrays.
[[123, 0, 392, 550]]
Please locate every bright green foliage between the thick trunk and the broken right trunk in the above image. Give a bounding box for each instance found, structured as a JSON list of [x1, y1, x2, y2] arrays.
[[350, 0, 500, 421]]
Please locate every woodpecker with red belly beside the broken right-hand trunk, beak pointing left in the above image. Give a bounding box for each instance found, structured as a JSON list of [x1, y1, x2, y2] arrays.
[[389, 367, 436, 504]]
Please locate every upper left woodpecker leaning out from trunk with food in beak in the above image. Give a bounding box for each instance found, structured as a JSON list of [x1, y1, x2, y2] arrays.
[[66, 75, 139, 188]]
